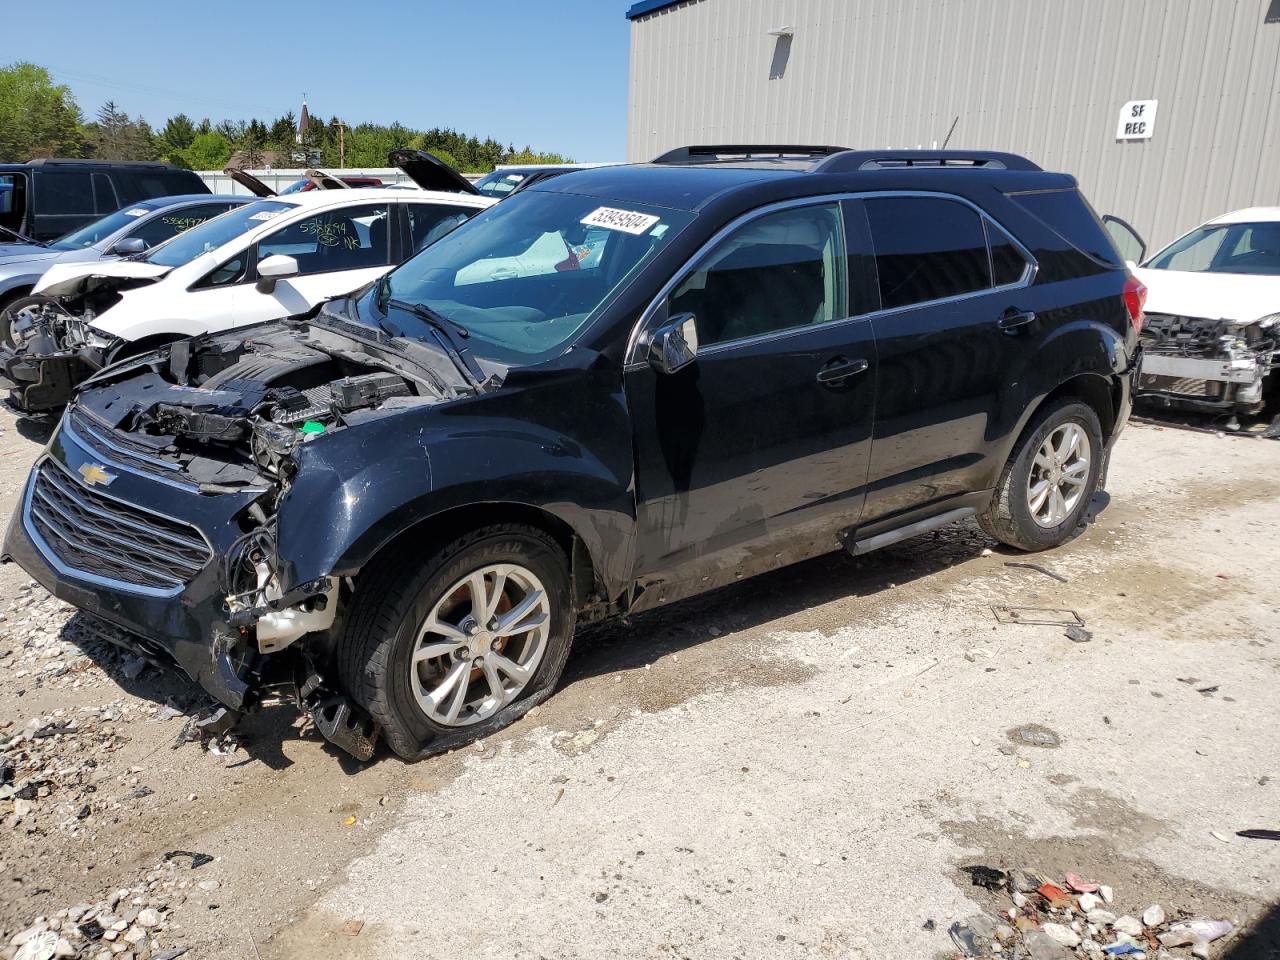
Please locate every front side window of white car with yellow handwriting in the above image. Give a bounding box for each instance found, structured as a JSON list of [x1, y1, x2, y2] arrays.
[[257, 204, 390, 275]]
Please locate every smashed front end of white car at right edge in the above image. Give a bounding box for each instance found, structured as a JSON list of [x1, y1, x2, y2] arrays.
[[1137, 314, 1280, 415]]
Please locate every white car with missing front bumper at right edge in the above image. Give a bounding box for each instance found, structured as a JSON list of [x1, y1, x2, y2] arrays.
[[1106, 207, 1280, 413]]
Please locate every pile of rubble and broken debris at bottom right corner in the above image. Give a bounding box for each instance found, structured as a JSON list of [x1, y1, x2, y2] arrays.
[[925, 865, 1235, 960]]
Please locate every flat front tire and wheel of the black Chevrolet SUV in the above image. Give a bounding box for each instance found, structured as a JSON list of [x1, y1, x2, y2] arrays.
[[337, 524, 575, 760]]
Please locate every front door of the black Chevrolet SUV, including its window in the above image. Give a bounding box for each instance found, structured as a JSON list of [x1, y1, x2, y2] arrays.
[[626, 202, 876, 608]]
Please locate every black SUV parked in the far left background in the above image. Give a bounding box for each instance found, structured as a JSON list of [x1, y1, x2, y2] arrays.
[[0, 160, 209, 241]]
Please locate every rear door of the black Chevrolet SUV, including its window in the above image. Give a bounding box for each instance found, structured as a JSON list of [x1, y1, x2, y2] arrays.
[[863, 195, 1038, 524]]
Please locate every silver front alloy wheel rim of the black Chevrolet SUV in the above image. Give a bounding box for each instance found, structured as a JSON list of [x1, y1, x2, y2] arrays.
[[410, 563, 550, 727]]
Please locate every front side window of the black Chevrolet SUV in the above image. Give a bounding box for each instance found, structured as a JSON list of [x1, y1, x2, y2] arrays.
[[667, 204, 845, 347]]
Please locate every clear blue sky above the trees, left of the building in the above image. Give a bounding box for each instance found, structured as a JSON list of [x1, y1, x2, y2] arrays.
[[0, 0, 631, 161]]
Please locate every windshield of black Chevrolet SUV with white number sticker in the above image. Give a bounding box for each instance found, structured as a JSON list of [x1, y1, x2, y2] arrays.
[[380, 191, 692, 362]]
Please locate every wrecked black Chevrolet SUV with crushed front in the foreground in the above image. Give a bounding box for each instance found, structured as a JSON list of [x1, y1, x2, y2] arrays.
[[4, 146, 1143, 758]]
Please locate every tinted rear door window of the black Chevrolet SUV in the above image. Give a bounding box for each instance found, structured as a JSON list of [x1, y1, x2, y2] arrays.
[[867, 197, 992, 310]]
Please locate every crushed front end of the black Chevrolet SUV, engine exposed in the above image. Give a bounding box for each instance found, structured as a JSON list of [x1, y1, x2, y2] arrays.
[[4, 316, 463, 755]]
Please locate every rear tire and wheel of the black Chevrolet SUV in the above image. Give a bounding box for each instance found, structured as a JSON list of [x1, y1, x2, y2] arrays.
[[978, 398, 1106, 550]]
